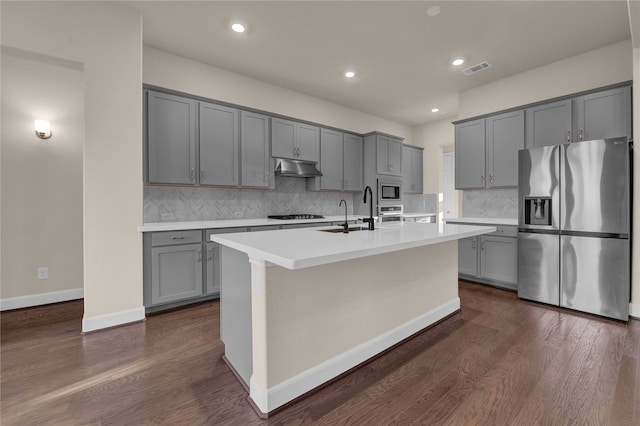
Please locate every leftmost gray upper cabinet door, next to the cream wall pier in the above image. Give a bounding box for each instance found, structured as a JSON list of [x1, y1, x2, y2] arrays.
[[147, 91, 196, 185]]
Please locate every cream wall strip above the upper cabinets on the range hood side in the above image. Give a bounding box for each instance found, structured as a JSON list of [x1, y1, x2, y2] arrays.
[[143, 46, 412, 144]]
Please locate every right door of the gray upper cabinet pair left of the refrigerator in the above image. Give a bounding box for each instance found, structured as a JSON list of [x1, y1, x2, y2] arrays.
[[486, 110, 524, 188]]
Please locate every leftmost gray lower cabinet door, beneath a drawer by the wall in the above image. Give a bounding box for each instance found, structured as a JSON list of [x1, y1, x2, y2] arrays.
[[151, 243, 203, 305]]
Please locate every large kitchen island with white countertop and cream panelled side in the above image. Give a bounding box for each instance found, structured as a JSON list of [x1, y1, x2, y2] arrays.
[[211, 222, 495, 416]]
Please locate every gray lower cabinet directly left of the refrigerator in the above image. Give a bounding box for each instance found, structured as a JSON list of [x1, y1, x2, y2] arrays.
[[448, 222, 518, 290]]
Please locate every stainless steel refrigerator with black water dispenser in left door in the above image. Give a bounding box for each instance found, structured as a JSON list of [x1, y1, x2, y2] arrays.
[[518, 138, 632, 321]]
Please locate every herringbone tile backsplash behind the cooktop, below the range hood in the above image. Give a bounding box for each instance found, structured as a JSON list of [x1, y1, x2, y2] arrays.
[[143, 177, 353, 223]]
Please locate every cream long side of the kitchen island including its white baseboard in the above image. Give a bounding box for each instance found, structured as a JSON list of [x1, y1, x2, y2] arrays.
[[251, 241, 460, 412]]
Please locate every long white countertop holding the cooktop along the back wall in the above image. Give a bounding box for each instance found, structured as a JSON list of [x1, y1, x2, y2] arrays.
[[138, 215, 363, 232]]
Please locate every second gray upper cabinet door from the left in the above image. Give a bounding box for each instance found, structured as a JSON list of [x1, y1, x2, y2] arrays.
[[199, 102, 240, 186]]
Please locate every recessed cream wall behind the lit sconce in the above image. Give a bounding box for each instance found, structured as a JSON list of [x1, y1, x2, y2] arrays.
[[0, 48, 84, 309]]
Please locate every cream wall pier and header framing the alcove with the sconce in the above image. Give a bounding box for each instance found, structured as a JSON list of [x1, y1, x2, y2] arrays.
[[0, 1, 144, 331]]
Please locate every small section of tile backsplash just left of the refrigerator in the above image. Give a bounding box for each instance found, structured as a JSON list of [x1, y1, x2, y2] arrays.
[[462, 188, 518, 219]]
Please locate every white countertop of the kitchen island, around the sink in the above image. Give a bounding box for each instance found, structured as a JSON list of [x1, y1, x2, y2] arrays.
[[211, 222, 496, 269]]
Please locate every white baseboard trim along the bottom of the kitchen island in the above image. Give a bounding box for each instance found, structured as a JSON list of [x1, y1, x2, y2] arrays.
[[249, 297, 460, 417]]
